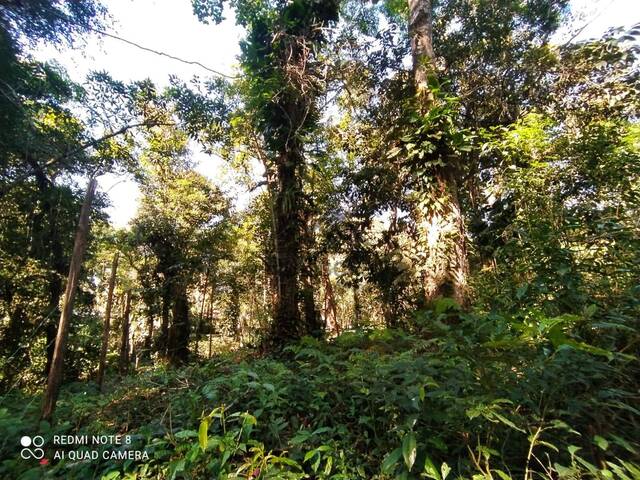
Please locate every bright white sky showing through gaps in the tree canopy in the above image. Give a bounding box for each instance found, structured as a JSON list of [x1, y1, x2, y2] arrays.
[[33, 0, 640, 227]]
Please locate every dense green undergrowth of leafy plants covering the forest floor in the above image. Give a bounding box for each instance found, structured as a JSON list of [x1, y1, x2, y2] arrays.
[[0, 310, 640, 480]]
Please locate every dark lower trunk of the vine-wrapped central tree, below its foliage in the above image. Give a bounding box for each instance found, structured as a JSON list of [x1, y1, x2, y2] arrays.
[[272, 158, 301, 344]]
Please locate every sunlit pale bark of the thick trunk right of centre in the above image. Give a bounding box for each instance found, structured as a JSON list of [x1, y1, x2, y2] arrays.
[[409, 0, 469, 306]]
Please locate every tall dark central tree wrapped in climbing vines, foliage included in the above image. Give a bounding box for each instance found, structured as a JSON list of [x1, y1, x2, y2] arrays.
[[193, 0, 339, 343]]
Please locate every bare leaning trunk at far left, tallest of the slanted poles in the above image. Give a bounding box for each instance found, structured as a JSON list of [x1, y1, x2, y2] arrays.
[[42, 178, 97, 421]]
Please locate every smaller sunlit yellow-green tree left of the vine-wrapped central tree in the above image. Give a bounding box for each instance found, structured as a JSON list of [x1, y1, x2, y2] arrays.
[[132, 127, 228, 362]]
